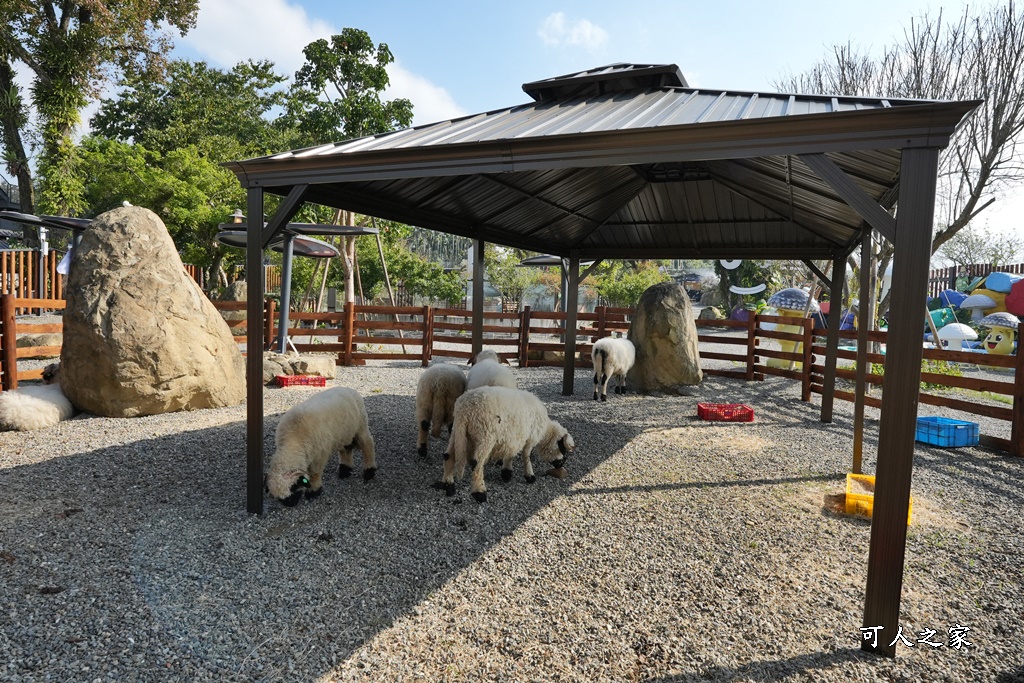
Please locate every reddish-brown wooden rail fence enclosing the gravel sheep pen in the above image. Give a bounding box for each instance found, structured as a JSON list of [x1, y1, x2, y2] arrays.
[[0, 294, 1024, 456]]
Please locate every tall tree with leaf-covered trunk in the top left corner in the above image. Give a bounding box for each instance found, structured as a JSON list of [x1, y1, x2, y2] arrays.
[[0, 0, 199, 224]]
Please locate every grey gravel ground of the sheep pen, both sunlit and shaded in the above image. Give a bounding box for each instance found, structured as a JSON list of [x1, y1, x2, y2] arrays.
[[0, 361, 1024, 683]]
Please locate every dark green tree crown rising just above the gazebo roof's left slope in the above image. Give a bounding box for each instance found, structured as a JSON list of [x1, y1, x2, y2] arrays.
[[287, 29, 413, 145]]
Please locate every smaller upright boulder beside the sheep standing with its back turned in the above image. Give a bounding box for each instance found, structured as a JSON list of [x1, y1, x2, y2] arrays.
[[628, 282, 703, 393]]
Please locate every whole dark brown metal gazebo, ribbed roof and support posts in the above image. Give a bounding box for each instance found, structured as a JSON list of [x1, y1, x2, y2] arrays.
[[227, 65, 979, 655]]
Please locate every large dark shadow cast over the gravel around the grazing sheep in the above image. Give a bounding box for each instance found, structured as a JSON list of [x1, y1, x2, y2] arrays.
[[0, 393, 655, 681]]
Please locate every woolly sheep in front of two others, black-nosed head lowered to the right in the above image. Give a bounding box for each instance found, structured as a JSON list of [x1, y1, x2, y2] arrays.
[[441, 387, 575, 503]]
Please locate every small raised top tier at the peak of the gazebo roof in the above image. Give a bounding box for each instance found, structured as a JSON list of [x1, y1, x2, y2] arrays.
[[522, 63, 689, 101]]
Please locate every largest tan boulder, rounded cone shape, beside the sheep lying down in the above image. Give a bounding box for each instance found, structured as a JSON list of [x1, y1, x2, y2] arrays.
[[60, 207, 246, 418]]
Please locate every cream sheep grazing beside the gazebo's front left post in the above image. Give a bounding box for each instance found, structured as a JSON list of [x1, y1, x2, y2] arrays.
[[266, 387, 377, 507]]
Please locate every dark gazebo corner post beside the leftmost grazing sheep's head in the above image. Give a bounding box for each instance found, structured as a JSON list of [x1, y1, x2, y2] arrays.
[[246, 185, 266, 515]]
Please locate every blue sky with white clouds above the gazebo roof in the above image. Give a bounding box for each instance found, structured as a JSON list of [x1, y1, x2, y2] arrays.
[[167, 0, 1024, 236]]
